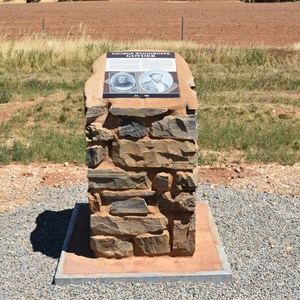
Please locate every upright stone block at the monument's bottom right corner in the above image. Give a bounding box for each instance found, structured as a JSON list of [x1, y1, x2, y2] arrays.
[[172, 215, 196, 256]]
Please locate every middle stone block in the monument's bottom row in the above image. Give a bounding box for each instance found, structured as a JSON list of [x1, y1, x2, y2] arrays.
[[133, 230, 170, 256]]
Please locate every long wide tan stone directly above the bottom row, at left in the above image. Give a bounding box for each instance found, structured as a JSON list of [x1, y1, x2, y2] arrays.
[[90, 206, 168, 237]]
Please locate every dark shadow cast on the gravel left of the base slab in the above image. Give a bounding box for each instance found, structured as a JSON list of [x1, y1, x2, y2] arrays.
[[30, 209, 73, 258]]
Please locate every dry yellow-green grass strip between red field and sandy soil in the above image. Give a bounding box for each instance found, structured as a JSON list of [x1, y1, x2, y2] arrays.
[[0, 37, 300, 164]]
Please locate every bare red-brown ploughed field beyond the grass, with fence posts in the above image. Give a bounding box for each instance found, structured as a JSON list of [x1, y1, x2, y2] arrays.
[[0, 1, 300, 46]]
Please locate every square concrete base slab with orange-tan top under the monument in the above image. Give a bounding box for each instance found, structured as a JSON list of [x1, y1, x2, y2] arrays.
[[54, 201, 232, 285]]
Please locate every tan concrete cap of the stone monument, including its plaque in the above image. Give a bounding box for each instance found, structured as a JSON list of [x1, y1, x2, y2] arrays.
[[85, 50, 197, 120]]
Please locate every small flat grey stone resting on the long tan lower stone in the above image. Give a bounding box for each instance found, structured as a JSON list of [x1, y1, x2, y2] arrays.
[[110, 198, 149, 216]]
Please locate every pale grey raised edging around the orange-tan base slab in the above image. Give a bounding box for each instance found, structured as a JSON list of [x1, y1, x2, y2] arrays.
[[53, 201, 232, 285]]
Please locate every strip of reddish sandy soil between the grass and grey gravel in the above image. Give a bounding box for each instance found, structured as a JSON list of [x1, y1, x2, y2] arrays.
[[0, 163, 300, 213]]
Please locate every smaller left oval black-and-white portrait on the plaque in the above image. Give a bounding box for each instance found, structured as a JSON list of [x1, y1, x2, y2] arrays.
[[109, 72, 136, 92]]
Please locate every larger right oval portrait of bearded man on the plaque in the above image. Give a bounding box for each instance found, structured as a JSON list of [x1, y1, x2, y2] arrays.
[[139, 70, 174, 93]]
